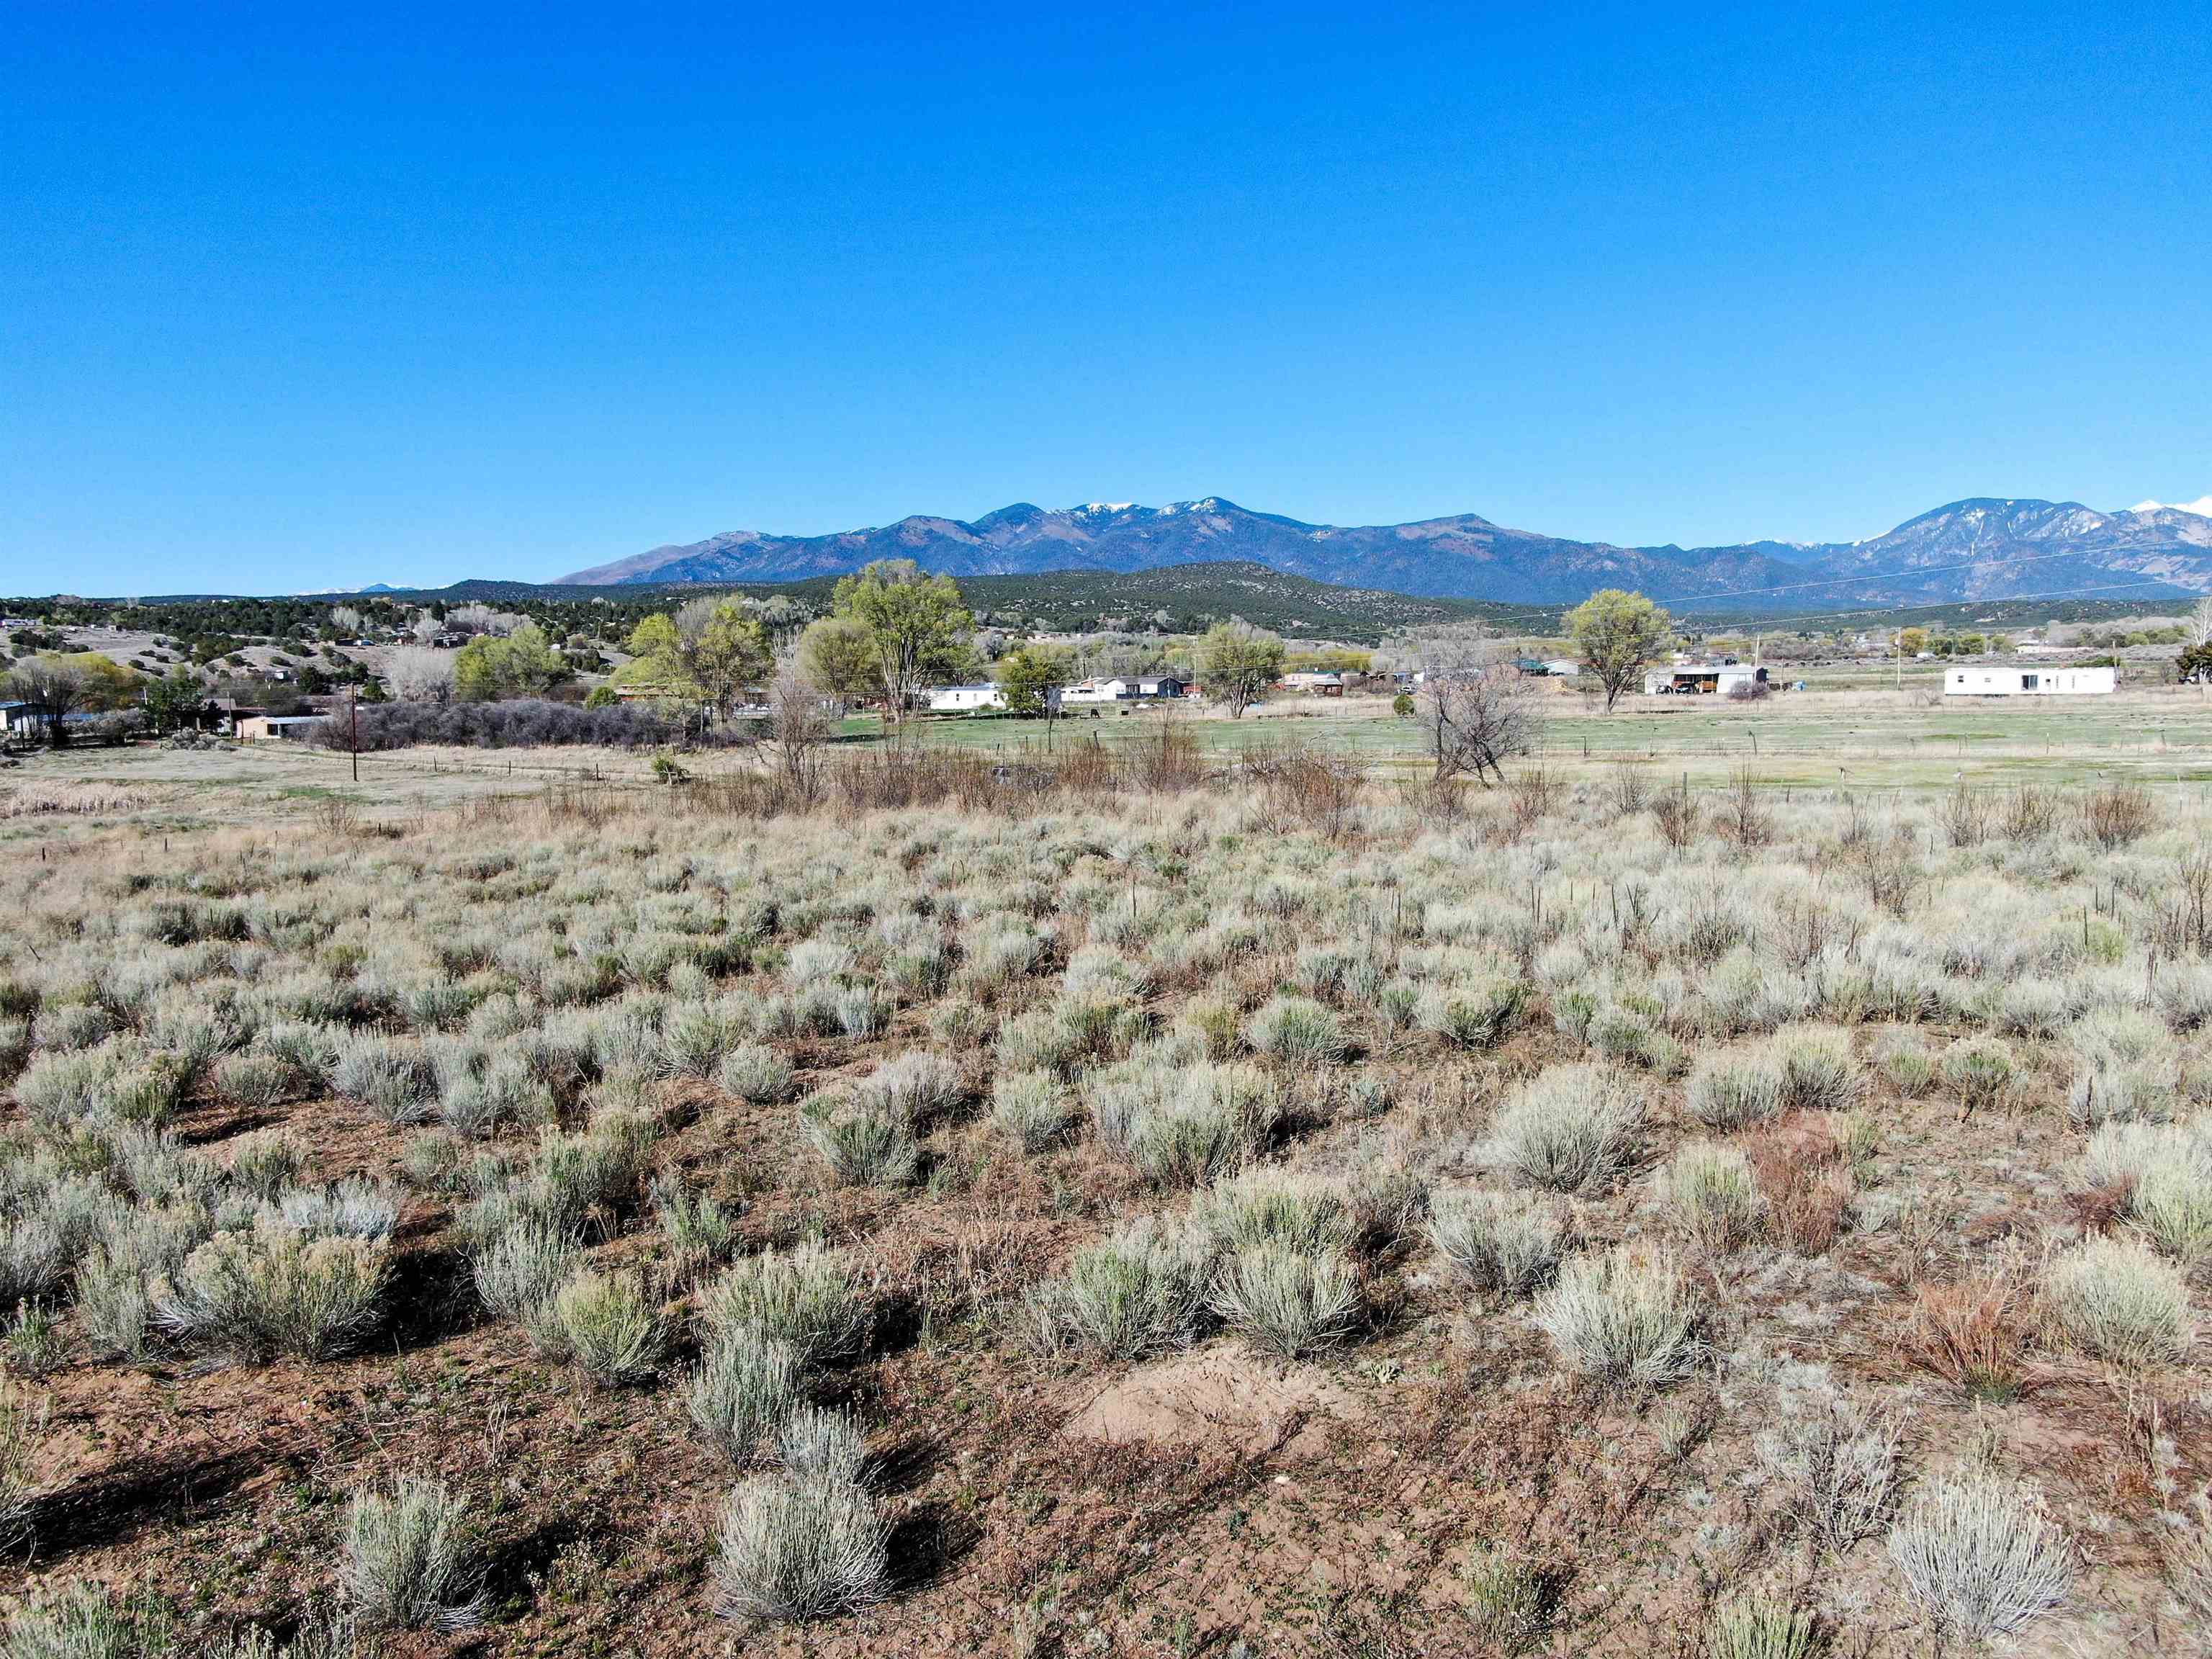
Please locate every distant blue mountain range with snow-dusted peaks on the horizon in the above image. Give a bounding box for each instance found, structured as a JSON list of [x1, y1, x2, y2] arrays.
[[562, 495, 2212, 613]]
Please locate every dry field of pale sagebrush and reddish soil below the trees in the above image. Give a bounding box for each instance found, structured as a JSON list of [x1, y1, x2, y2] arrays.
[[0, 716, 2212, 1659]]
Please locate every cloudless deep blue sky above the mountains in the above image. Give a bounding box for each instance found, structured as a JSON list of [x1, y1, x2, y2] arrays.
[[0, 2, 2212, 593]]
